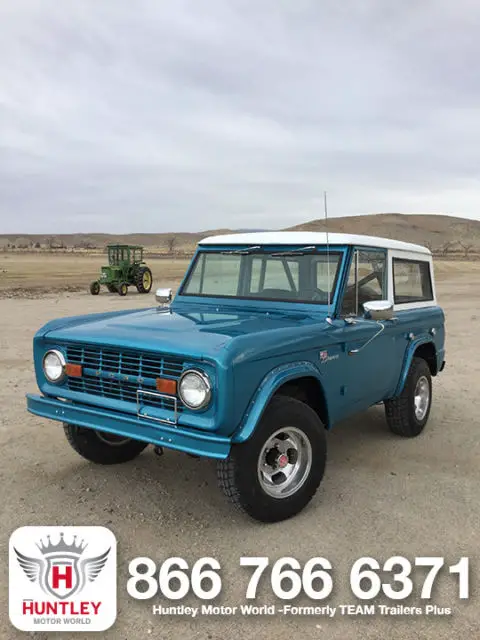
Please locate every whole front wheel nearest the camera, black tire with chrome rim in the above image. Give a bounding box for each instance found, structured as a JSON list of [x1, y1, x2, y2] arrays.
[[217, 395, 326, 522]]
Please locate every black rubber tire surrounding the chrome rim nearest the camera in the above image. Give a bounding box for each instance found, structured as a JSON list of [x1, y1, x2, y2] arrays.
[[217, 395, 327, 522]]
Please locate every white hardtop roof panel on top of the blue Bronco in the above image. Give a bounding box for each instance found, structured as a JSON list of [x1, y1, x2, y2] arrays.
[[199, 231, 430, 255]]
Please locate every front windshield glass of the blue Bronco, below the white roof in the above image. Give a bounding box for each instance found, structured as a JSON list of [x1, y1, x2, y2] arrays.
[[180, 247, 342, 304]]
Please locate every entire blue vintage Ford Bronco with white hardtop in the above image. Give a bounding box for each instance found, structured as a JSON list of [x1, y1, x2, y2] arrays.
[[27, 232, 445, 522]]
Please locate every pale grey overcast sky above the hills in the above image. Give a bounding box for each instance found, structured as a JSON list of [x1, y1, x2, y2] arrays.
[[0, 0, 480, 233]]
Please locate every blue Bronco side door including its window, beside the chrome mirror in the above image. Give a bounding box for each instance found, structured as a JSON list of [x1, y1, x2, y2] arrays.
[[340, 248, 395, 413]]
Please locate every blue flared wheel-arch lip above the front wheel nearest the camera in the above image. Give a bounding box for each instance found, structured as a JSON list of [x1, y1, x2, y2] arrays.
[[232, 360, 321, 442]]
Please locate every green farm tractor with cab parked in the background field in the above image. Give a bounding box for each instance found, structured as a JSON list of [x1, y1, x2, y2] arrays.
[[90, 244, 153, 296]]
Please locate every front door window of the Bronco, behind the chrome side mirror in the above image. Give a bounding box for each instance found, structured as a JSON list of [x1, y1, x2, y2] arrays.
[[341, 249, 387, 316]]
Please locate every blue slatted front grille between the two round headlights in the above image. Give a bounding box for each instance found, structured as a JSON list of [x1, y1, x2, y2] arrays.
[[66, 344, 184, 411]]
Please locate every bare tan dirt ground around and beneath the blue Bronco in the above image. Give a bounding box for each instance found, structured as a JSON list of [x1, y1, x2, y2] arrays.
[[0, 263, 480, 640]]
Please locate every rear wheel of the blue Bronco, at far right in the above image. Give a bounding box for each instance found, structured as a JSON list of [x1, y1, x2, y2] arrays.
[[385, 358, 432, 438]]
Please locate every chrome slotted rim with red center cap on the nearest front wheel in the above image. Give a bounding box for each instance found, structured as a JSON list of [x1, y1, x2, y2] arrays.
[[257, 427, 312, 498]]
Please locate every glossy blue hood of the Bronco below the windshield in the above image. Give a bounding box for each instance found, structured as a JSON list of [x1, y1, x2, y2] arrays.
[[42, 305, 328, 360]]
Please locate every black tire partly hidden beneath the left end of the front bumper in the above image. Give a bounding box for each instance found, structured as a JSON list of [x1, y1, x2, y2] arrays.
[[63, 424, 148, 464]]
